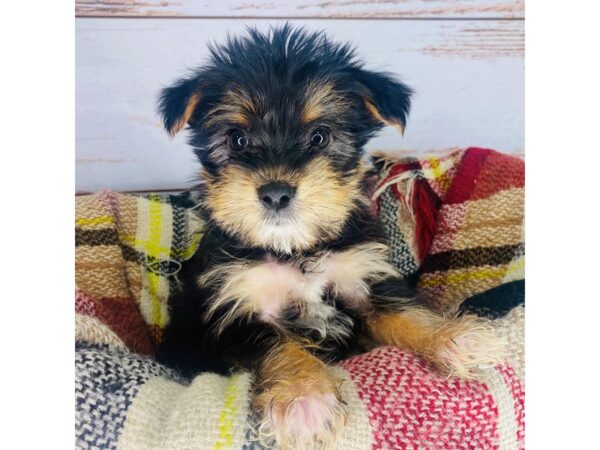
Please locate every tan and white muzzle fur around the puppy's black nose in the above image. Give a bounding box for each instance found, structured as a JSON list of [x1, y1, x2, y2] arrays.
[[201, 156, 366, 253]]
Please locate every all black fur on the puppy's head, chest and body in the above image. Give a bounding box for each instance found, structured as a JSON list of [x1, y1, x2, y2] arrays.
[[152, 25, 414, 374]]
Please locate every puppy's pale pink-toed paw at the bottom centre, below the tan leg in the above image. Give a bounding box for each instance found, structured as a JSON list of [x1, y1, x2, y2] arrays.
[[253, 384, 347, 450]]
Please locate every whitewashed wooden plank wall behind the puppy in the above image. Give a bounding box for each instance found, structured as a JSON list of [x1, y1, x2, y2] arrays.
[[76, 0, 524, 192]]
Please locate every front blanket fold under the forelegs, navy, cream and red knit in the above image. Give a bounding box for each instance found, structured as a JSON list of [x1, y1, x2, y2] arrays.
[[76, 312, 524, 450]]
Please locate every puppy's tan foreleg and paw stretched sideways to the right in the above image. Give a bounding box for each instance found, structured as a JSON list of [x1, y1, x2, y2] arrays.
[[367, 307, 505, 379]]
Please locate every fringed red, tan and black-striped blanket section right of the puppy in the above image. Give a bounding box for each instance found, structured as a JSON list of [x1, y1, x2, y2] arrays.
[[374, 148, 525, 312]]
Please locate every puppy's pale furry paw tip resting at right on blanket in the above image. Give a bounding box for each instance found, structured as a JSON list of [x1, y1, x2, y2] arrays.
[[432, 316, 506, 379]]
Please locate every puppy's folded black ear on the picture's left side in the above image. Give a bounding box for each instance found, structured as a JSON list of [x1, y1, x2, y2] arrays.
[[158, 78, 200, 136]]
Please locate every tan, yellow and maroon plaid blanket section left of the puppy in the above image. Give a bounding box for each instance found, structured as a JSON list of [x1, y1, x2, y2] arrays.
[[75, 191, 202, 348]]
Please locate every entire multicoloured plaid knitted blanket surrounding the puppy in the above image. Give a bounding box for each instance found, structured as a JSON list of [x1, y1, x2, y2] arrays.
[[75, 149, 524, 450]]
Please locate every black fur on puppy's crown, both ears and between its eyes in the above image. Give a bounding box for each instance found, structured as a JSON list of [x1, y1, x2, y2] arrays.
[[159, 25, 412, 175]]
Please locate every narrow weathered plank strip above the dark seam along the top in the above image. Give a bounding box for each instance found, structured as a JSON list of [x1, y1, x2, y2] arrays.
[[75, 0, 525, 19]]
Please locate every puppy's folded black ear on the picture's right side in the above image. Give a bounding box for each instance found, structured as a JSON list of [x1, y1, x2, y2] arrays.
[[357, 69, 413, 134]]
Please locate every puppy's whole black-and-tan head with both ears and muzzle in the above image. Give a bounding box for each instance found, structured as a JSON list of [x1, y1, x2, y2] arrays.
[[159, 25, 411, 253]]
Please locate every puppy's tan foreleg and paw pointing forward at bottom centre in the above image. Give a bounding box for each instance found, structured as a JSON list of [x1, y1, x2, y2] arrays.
[[252, 341, 348, 450]]
